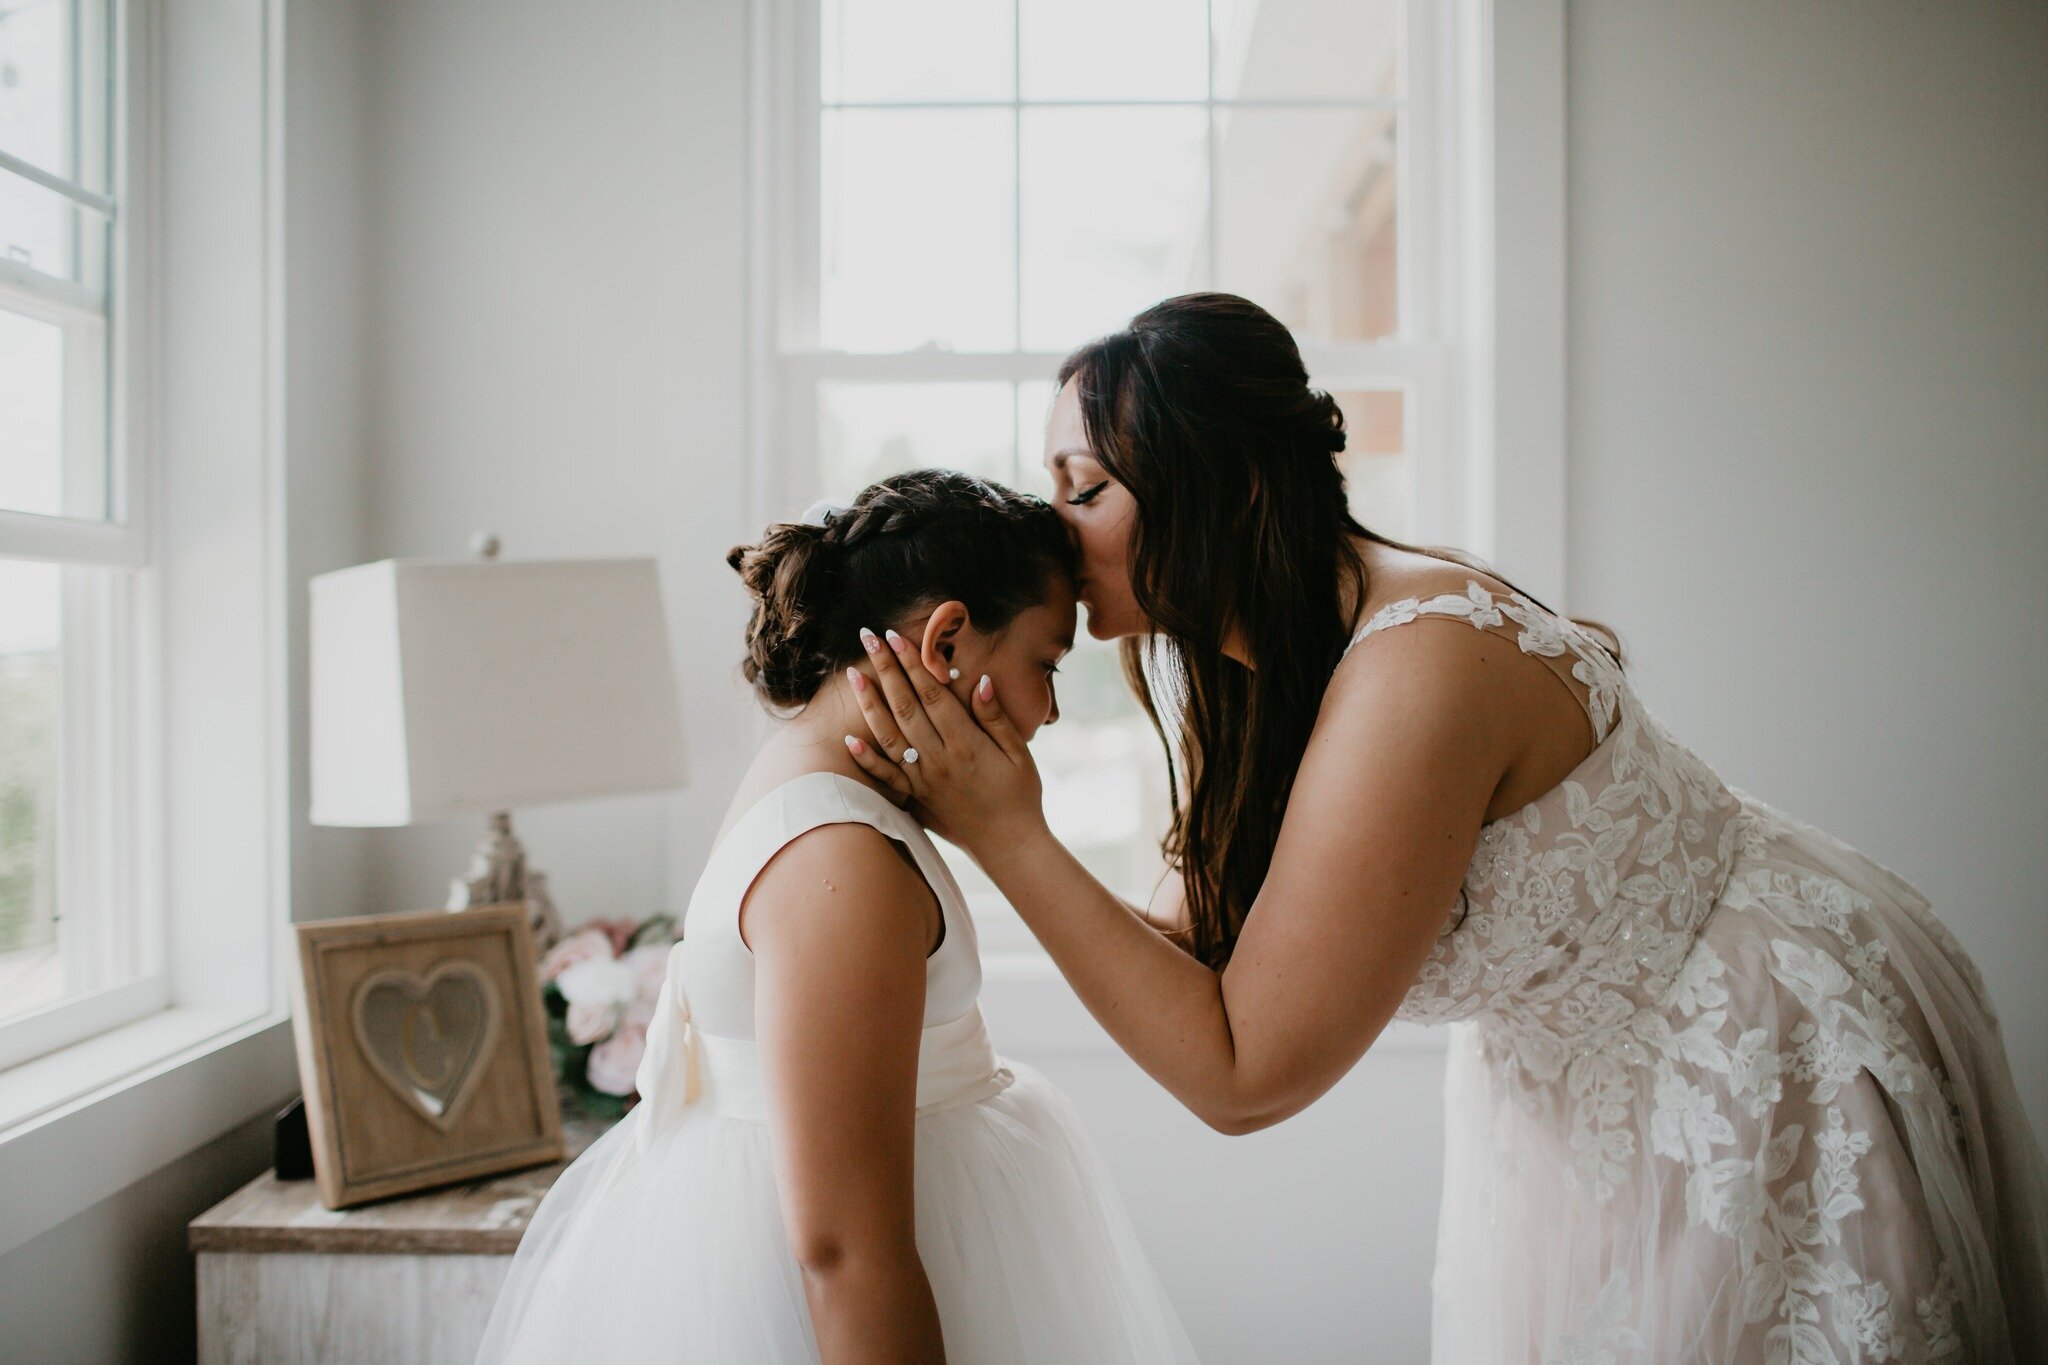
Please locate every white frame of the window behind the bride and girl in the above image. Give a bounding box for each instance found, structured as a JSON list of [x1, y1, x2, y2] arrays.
[[745, 0, 1569, 1052]]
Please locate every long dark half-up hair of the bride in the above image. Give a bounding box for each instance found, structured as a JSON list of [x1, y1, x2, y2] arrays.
[[1059, 293, 1605, 970]]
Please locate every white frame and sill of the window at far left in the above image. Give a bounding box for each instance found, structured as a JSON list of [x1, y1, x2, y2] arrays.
[[0, 0, 297, 1254]]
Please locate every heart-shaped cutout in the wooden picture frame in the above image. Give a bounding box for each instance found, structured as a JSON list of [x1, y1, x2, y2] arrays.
[[350, 958, 502, 1130]]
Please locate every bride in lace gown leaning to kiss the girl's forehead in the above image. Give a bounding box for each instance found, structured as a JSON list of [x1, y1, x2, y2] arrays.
[[852, 295, 2048, 1365]]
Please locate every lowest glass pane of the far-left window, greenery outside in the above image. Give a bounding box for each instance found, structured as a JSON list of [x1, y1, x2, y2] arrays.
[[0, 561, 63, 1017]]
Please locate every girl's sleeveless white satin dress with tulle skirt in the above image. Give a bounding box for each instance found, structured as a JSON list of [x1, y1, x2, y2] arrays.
[[477, 774, 1194, 1365]]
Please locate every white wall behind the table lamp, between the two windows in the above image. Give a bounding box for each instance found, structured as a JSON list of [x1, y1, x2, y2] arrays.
[[362, 0, 754, 921]]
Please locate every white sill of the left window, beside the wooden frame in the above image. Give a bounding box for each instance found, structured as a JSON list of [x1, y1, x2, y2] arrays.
[[0, 1007, 299, 1254]]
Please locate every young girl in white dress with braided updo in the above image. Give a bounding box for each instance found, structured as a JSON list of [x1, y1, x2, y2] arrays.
[[479, 471, 1194, 1365]]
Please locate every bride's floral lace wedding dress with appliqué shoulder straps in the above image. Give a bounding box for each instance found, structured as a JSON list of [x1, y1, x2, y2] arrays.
[[1354, 581, 2048, 1365]]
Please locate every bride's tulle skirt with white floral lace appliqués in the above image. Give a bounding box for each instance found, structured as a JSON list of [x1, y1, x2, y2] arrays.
[[1434, 802, 2048, 1365]]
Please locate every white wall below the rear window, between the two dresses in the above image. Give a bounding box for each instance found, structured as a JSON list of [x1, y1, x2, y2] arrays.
[[1019, 1039, 1444, 1365]]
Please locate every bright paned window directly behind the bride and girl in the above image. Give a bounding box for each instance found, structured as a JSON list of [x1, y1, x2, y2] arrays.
[[754, 0, 1462, 945]]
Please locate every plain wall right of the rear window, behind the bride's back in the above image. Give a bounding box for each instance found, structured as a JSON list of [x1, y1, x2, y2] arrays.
[[1569, 0, 2048, 1132]]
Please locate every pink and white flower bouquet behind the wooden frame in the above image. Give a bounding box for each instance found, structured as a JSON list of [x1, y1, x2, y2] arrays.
[[539, 915, 676, 1119]]
